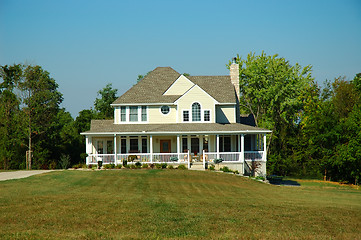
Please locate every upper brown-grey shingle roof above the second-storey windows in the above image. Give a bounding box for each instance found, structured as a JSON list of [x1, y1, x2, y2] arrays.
[[113, 67, 236, 104]]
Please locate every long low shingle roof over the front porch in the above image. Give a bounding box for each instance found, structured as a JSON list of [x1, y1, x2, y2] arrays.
[[83, 120, 270, 135]]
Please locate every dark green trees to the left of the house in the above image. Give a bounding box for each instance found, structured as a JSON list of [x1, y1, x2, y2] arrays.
[[0, 64, 117, 170]]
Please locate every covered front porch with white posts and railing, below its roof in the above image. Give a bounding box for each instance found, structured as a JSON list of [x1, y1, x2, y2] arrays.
[[86, 133, 267, 175]]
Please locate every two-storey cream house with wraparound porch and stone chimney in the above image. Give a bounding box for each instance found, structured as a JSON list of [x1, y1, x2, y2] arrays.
[[82, 63, 271, 175]]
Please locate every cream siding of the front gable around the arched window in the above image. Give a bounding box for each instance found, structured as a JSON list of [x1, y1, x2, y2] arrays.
[[177, 86, 216, 123]]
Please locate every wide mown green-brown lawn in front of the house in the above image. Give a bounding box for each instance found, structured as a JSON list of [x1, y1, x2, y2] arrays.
[[0, 170, 361, 239]]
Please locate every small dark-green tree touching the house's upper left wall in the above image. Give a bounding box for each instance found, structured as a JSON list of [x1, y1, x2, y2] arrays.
[[94, 83, 118, 119]]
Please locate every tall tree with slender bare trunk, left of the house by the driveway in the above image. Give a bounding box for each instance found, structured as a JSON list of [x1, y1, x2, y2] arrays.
[[20, 65, 63, 169]]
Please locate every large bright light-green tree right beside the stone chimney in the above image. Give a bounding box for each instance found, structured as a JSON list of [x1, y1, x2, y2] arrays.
[[228, 52, 313, 157]]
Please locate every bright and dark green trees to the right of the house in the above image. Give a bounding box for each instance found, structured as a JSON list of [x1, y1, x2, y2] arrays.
[[228, 52, 361, 183]]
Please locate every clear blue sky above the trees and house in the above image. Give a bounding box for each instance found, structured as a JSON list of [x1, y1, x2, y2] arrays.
[[0, 0, 361, 117]]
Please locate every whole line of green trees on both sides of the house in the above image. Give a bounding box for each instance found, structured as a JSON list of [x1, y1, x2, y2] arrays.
[[0, 52, 361, 183]]
